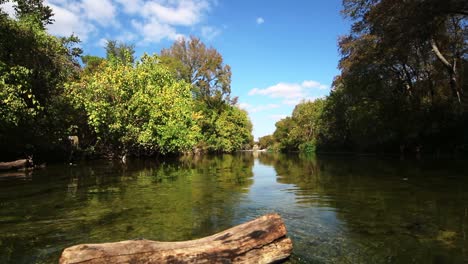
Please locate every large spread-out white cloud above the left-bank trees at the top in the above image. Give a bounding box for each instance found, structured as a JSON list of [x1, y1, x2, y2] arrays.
[[40, 0, 216, 45]]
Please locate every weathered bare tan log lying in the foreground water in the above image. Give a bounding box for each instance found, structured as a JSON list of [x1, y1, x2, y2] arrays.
[[60, 214, 292, 264]]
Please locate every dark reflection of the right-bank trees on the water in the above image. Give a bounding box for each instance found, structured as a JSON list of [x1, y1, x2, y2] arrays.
[[259, 155, 468, 263]]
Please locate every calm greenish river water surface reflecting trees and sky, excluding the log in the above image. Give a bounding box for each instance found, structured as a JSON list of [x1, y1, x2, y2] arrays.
[[0, 153, 468, 263]]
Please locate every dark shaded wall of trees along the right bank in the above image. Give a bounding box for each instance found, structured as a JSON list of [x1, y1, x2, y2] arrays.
[[268, 0, 468, 153]]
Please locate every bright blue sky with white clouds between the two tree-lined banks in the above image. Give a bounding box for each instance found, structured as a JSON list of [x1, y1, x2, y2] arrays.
[[2, 0, 350, 139]]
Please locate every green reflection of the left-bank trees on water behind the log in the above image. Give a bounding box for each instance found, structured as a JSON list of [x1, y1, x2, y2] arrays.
[[0, 155, 253, 263]]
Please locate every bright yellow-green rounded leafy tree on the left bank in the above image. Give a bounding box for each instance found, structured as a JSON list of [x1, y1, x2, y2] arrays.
[[67, 55, 199, 155]]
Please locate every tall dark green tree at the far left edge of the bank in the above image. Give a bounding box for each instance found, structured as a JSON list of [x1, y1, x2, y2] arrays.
[[0, 1, 80, 158]]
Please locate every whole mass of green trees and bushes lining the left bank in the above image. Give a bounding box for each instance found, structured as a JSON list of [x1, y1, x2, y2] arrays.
[[0, 0, 253, 159]]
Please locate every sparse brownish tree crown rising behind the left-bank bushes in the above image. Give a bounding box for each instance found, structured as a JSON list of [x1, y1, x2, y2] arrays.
[[161, 36, 231, 107]]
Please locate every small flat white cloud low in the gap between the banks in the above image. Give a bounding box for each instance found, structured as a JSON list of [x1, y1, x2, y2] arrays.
[[249, 80, 328, 105]]
